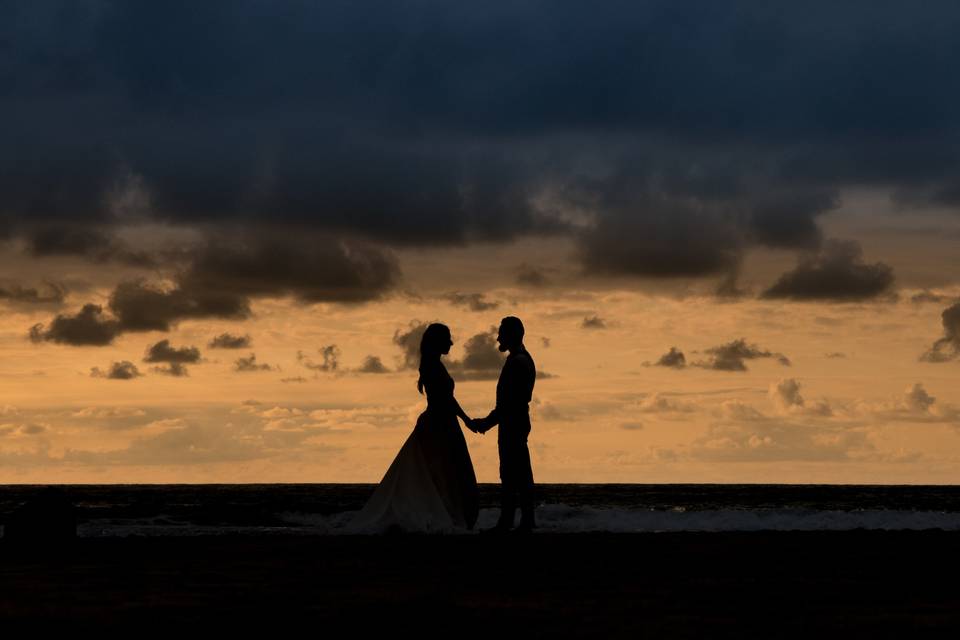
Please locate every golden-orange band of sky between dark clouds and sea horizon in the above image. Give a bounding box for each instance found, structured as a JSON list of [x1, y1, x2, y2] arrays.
[[0, 202, 960, 483]]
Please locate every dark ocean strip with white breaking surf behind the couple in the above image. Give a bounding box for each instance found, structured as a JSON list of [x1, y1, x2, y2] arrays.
[[0, 484, 960, 538]]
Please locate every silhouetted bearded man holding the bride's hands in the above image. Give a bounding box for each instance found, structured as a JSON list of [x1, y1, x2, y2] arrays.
[[471, 316, 537, 533]]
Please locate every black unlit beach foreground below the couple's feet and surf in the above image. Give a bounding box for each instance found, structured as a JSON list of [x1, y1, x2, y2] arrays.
[[0, 531, 960, 638]]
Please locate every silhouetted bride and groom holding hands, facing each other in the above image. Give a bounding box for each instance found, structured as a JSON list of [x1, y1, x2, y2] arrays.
[[353, 316, 536, 534]]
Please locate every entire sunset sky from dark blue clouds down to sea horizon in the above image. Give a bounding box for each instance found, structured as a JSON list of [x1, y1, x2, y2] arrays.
[[0, 0, 960, 484]]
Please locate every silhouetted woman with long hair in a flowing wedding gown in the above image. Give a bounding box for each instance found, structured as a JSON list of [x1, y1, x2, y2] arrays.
[[351, 323, 479, 532]]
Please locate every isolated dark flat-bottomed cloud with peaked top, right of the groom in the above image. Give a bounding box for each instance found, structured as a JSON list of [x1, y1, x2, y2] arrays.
[[763, 240, 893, 301]]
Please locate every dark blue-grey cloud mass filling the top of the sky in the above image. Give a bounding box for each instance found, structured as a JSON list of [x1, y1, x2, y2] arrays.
[[9, 0, 960, 278]]
